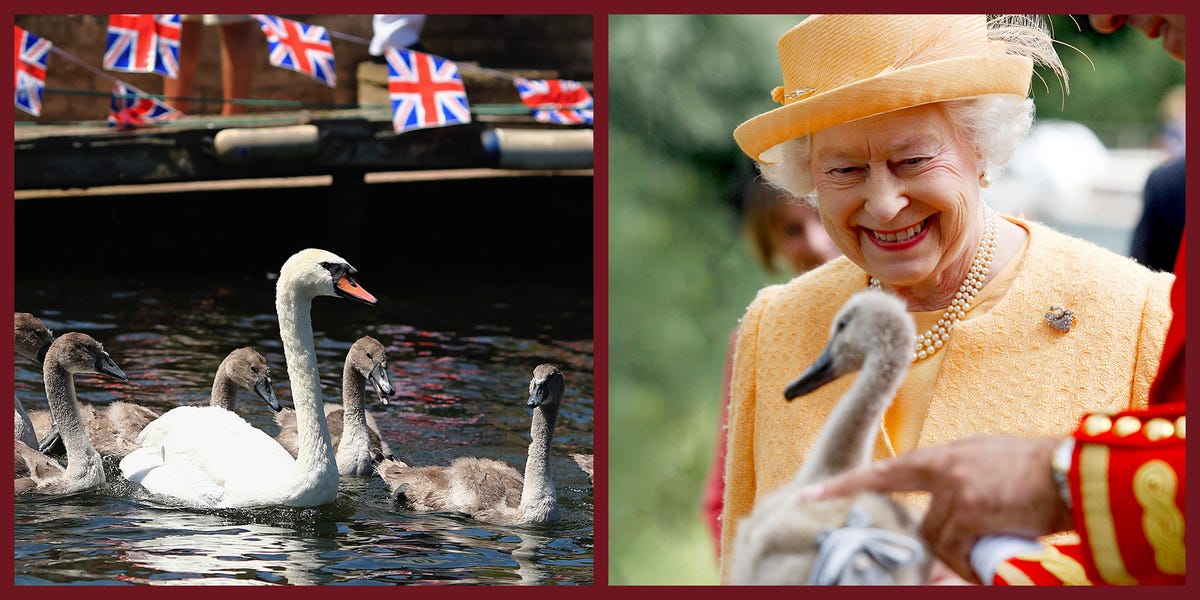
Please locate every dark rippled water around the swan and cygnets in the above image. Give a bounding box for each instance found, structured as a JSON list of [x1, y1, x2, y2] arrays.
[[14, 277, 593, 584]]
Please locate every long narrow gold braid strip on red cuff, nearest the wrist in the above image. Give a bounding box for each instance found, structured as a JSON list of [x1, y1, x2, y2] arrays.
[[1076, 444, 1138, 586]]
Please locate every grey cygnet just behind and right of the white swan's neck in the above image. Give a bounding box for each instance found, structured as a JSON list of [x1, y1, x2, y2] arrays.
[[275, 336, 396, 475]]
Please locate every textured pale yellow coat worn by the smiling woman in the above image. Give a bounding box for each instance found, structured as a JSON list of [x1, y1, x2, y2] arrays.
[[721, 217, 1175, 580]]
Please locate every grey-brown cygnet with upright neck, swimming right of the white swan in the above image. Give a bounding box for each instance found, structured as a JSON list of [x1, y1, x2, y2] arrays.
[[378, 365, 565, 524]]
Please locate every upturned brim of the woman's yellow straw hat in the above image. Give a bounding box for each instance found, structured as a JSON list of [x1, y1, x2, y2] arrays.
[[733, 55, 1033, 163]]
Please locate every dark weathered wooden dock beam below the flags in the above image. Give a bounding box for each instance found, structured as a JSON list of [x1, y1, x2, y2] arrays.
[[13, 109, 585, 190]]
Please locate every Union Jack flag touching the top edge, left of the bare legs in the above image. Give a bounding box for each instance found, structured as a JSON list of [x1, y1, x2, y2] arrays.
[[104, 14, 181, 78]]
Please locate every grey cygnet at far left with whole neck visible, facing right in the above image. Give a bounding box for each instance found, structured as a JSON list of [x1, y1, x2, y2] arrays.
[[14, 331, 128, 494]]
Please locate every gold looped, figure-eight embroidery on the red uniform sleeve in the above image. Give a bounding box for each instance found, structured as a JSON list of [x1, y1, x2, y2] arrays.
[[1133, 460, 1187, 575]]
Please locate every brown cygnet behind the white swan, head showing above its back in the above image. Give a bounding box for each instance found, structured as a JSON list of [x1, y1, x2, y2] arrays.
[[29, 347, 282, 457]]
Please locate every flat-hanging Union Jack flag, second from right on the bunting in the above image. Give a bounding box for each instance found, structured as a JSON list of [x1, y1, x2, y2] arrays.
[[386, 48, 470, 133]]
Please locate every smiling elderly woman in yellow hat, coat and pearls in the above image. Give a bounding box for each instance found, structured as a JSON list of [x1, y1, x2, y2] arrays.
[[721, 14, 1174, 576]]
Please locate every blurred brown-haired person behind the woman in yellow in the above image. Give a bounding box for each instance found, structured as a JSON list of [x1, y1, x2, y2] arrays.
[[701, 172, 841, 557]]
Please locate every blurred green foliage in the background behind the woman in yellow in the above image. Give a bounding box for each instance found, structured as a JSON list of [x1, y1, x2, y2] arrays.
[[608, 14, 1184, 584]]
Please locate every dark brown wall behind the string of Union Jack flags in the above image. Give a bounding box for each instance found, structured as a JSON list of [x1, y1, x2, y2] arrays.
[[16, 14, 594, 122]]
